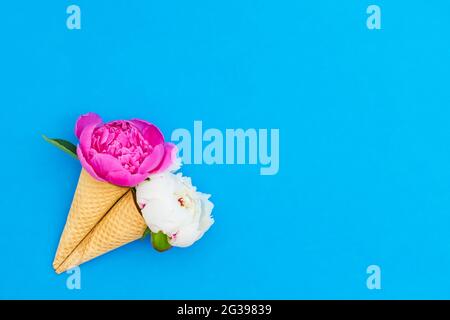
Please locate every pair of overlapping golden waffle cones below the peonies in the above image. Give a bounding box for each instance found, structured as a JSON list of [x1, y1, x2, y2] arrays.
[[53, 169, 147, 274]]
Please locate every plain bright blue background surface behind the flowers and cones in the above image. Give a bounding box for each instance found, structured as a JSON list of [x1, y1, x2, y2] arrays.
[[0, 0, 450, 299]]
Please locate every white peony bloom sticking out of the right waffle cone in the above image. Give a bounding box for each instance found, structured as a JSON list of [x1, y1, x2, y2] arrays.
[[136, 172, 214, 247]]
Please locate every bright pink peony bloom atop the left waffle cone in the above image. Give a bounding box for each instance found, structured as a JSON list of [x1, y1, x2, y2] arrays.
[[75, 113, 177, 187]]
